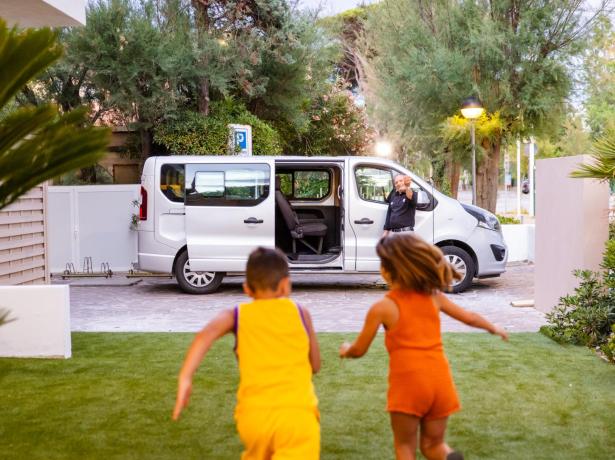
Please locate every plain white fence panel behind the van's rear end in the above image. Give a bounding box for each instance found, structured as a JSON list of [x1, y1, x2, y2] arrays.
[[47, 185, 140, 273]]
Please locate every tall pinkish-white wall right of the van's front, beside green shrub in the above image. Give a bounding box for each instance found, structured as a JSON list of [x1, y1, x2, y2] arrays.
[[534, 155, 609, 312]]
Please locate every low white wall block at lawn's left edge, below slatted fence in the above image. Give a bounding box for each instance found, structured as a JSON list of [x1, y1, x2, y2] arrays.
[[0, 285, 71, 358]]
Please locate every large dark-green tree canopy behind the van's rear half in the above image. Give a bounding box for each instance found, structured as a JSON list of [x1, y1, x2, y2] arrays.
[[25, 0, 346, 159]]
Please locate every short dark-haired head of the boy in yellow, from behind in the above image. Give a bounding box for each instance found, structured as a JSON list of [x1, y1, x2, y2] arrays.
[[246, 247, 288, 291]]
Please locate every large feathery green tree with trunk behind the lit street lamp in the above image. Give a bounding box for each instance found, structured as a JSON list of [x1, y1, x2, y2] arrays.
[[361, 0, 608, 210]]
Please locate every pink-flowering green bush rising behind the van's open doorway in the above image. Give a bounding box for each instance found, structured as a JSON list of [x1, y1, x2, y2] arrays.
[[286, 82, 375, 156]]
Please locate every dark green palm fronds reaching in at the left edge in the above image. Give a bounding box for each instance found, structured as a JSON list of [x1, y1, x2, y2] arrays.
[[0, 19, 109, 209]]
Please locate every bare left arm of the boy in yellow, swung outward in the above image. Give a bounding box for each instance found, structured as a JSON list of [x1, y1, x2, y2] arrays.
[[173, 310, 235, 420]]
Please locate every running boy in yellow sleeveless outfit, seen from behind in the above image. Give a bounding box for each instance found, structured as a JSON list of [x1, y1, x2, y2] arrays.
[[173, 248, 320, 460]]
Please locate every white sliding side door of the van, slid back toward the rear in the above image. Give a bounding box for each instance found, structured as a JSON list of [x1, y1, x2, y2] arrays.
[[186, 157, 275, 272]]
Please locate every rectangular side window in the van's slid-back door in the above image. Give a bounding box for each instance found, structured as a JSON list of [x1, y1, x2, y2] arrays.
[[186, 163, 270, 206]]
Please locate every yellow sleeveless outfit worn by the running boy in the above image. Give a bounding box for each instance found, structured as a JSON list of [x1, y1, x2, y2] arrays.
[[235, 298, 320, 460]]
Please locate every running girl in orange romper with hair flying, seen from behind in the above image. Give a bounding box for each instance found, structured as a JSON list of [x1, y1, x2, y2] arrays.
[[340, 233, 508, 460]]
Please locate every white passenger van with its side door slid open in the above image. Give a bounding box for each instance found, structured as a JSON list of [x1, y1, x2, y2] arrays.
[[139, 156, 508, 294]]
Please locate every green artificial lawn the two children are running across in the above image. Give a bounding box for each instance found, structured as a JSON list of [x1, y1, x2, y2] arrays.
[[0, 333, 615, 459]]
